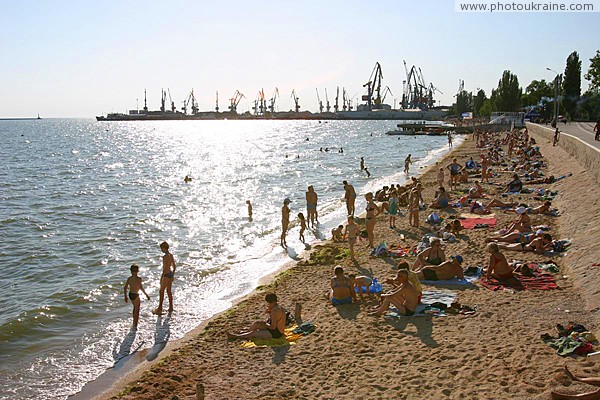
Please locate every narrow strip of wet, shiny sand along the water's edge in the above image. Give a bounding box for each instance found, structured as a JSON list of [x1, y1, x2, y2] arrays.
[[78, 135, 467, 400]]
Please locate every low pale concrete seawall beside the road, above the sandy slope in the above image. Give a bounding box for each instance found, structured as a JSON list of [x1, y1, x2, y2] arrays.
[[527, 123, 600, 183]]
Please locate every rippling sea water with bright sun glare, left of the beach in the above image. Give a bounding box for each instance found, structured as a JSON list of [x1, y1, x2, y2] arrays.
[[0, 119, 457, 399]]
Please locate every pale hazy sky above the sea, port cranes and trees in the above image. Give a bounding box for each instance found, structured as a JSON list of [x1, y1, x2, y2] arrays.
[[0, 0, 600, 118]]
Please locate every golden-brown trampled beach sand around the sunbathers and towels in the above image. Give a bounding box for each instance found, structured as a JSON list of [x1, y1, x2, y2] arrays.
[[98, 133, 600, 399]]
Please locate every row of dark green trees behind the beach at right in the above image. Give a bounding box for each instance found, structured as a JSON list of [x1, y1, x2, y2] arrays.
[[450, 50, 600, 121]]
